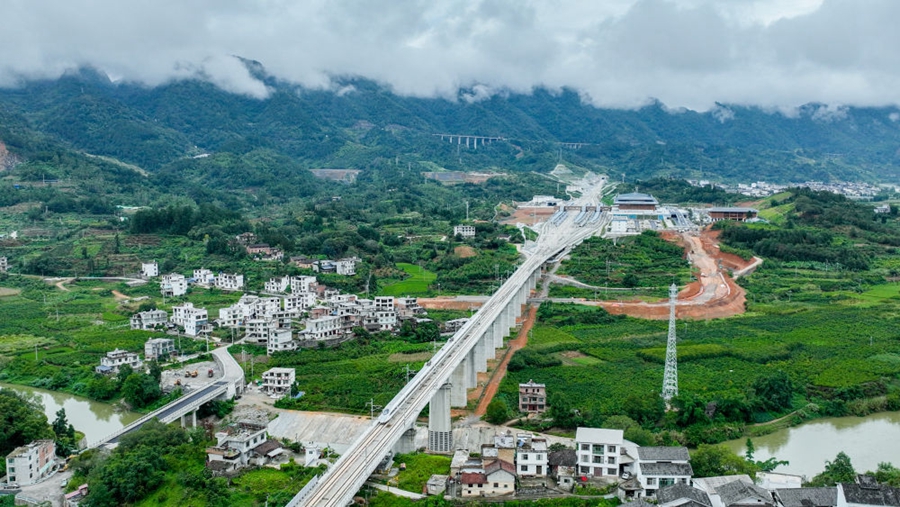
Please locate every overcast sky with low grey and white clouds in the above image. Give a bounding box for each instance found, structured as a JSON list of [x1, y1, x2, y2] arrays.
[[0, 0, 900, 110]]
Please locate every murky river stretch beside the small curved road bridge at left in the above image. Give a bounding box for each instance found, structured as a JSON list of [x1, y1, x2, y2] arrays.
[[0, 383, 141, 442]]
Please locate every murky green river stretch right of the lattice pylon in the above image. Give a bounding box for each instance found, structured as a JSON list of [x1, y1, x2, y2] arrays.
[[725, 412, 900, 479]]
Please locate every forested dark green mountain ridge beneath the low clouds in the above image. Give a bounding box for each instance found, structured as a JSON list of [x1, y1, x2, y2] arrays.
[[0, 66, 900, 186]]
